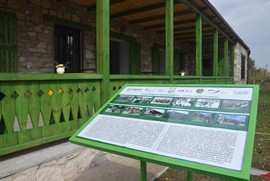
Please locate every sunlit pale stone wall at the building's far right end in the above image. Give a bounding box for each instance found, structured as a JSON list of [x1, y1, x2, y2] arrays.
[[234, 43, 249, 84]]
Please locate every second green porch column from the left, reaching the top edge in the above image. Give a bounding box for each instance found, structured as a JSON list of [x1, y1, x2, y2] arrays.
[[165, 0, 174, 83]]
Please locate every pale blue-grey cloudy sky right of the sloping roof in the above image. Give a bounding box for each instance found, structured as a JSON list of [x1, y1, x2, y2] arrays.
[[209, 0, 270, 71]]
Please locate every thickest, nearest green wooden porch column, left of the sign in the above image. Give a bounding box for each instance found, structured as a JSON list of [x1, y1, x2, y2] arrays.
[[96, 0, 110, 104]]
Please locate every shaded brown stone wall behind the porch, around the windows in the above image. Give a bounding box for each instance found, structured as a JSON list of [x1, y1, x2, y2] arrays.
[[0, 0, 168, 73]]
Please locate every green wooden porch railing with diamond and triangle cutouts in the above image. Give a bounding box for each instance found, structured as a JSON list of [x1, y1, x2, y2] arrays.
[[0, 73, 233, 155]]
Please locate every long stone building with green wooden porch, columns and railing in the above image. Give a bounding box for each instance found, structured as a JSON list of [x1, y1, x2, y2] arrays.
[[0, 0, 250, 180]]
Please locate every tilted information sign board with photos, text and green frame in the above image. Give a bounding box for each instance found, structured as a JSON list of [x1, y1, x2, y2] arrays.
[[71, 85, 258, 180]]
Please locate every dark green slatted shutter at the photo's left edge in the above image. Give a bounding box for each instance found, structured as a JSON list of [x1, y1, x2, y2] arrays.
[[0, 11, 18, 72]]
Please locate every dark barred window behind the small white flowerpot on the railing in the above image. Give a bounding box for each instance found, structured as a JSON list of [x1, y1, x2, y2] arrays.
[[54, 24, 82, 73]]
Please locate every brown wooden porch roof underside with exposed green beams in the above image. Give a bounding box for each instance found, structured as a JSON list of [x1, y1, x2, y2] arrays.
[[69, 0, 250, 52]]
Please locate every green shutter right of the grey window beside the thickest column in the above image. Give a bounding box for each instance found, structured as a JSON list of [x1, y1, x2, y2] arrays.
[[130, 40, 141, 74]]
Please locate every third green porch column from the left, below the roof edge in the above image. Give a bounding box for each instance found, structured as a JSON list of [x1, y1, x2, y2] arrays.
[[196, 15, 202, 76]]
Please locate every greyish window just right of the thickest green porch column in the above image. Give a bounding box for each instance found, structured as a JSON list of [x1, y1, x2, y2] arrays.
[[110, 38, 130, 74]]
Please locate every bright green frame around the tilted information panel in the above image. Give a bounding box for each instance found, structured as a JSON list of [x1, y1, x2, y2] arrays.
[[70, 84, 259, 181]]
